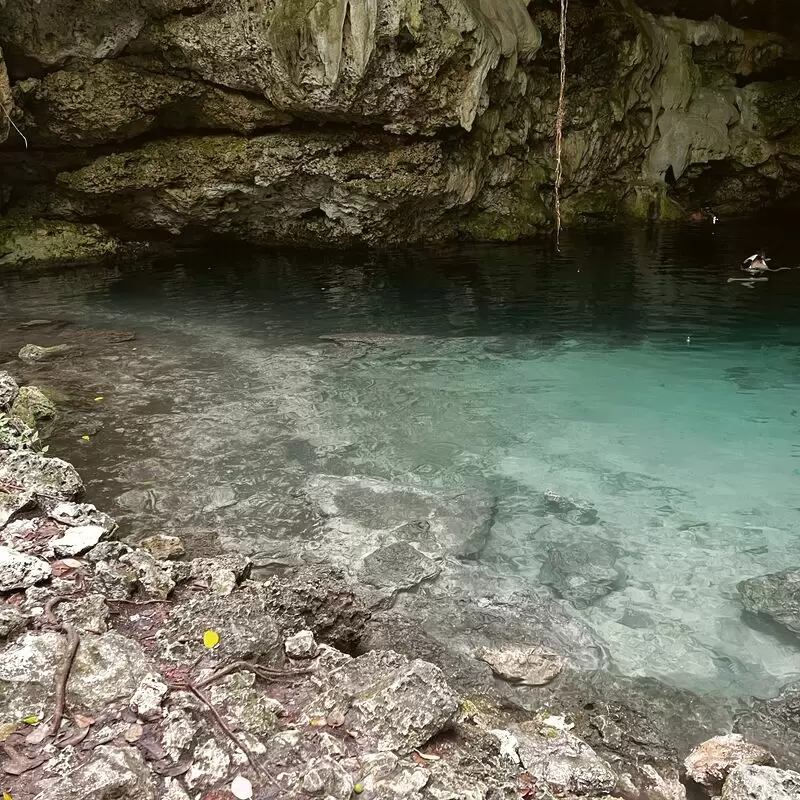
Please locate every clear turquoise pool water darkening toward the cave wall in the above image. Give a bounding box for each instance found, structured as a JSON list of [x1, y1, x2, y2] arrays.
[[0, 223, 800, 695]]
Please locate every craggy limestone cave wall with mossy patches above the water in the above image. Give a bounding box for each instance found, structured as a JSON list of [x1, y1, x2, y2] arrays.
[[0, 0, 800, 263]]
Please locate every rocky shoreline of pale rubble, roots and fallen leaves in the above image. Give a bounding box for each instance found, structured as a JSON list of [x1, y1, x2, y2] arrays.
[[0, 362, 800, 800]]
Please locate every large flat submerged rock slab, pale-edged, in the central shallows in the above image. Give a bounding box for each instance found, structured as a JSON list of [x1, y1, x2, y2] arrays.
[[305, 475, 495, 568]]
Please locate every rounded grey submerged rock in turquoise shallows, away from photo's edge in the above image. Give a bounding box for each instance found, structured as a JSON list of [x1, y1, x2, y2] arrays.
[[539, 541, 623, 608]]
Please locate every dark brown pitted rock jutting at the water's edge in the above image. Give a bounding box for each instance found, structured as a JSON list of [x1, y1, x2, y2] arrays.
[[264, 567, 370, 650]]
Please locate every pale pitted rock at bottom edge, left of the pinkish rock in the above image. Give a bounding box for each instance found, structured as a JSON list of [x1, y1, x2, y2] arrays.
[[517, 722, 617, 796]]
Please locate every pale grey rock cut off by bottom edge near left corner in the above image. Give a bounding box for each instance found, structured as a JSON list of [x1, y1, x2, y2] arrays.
[[34, 746, 157, 800]]
